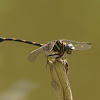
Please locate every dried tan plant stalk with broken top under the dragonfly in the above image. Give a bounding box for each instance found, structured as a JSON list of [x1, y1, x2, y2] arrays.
[[48, 59, 73, 100]]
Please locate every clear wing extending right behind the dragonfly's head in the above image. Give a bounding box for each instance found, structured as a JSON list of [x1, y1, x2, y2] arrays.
[[62, 39, 91, 50]]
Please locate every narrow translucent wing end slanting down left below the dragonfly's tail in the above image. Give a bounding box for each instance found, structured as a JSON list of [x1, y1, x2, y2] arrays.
[[28, 47, 43, 62]]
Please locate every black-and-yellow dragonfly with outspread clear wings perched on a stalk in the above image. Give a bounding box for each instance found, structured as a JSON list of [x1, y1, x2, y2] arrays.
[[0, 37, 91, 62]]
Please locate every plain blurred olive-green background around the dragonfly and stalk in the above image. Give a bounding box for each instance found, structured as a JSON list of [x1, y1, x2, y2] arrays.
[[0, 0, 100, 100]]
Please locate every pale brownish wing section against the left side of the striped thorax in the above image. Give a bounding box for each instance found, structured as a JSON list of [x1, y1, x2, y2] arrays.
[[43, 41, 56, 56]]
